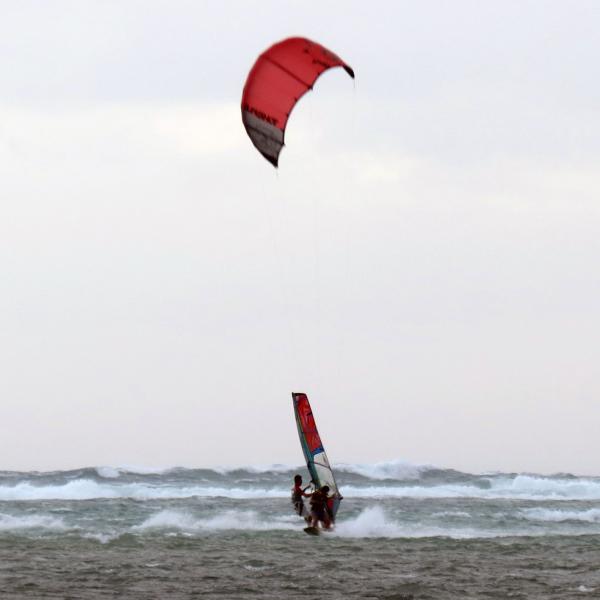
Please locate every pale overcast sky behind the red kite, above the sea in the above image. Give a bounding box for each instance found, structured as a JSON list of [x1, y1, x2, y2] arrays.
[[0, 0, 600, 474]]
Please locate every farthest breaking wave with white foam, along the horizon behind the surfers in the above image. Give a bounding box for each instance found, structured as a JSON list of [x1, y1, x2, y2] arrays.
[[0, 464, 600, 501]]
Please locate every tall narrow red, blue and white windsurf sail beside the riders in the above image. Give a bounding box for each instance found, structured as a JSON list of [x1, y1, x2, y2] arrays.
[[292, 393, 342, 521]]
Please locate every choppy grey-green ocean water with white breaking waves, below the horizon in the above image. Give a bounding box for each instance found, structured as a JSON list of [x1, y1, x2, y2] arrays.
[[0, 461, 600, 600]]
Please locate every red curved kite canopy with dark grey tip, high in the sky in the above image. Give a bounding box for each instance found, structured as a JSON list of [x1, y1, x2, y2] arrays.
[[242, 38, 354, 167]]
